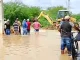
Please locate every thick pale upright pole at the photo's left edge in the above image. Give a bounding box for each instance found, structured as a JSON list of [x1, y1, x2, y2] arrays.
[[0, 0, 4, 35]]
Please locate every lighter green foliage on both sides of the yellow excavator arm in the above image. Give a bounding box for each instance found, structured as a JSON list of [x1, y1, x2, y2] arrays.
[[39, 6, 66, 27]]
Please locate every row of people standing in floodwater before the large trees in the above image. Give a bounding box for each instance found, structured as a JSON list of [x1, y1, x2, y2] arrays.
[[4, 18, 41, 35]]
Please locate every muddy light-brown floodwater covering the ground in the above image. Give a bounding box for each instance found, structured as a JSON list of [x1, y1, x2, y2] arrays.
[[0, 30, 71, 60]]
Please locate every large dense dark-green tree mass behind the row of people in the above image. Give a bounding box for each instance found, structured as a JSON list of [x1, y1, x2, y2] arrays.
[[4, 2, 41, 24]]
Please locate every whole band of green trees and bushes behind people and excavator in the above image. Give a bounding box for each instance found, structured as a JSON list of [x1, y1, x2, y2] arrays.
[[4, 2, 80, 27]]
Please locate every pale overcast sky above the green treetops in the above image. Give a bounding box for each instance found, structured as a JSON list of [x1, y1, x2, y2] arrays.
[[3, 0, 80, 13]]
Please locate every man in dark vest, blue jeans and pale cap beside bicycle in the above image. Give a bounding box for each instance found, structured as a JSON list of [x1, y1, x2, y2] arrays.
[[59, 16, 80, 56]]
